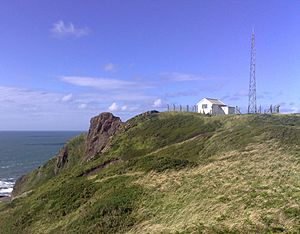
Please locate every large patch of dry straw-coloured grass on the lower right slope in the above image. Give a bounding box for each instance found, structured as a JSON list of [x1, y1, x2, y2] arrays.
[[129, 142, 300, 233]]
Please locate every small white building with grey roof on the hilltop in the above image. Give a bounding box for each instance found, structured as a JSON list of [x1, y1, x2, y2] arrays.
[[197, 98, 235, 115]]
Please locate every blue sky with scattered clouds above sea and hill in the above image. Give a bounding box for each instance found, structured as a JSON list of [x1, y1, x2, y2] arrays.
[[0, 0, 300, 130]]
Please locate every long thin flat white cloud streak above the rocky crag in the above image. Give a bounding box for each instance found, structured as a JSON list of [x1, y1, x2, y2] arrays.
[[60, 76, 143, 90]]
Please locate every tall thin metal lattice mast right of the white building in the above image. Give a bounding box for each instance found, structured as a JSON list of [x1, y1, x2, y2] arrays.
[[248, 30, 257, 114]]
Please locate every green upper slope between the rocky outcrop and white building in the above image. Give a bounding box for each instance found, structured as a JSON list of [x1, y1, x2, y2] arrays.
[[110, 113, 222, 160]]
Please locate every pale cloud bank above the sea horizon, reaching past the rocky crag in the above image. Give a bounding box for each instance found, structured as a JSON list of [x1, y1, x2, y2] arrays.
[[0, 85, 155, 130]]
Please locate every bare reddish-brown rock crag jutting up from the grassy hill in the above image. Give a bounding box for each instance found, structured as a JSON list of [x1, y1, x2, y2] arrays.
[[85, 112, 122, 160]]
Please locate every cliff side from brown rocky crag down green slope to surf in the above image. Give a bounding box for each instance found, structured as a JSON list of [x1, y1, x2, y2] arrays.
[[12, 112, 122, 197]]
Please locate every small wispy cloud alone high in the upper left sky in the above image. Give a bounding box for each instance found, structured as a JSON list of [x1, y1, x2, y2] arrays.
[[50, 20, 89, 38]]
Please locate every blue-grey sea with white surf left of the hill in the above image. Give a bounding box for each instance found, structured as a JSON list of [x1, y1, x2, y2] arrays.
[[0, 131, 81, 197]]
